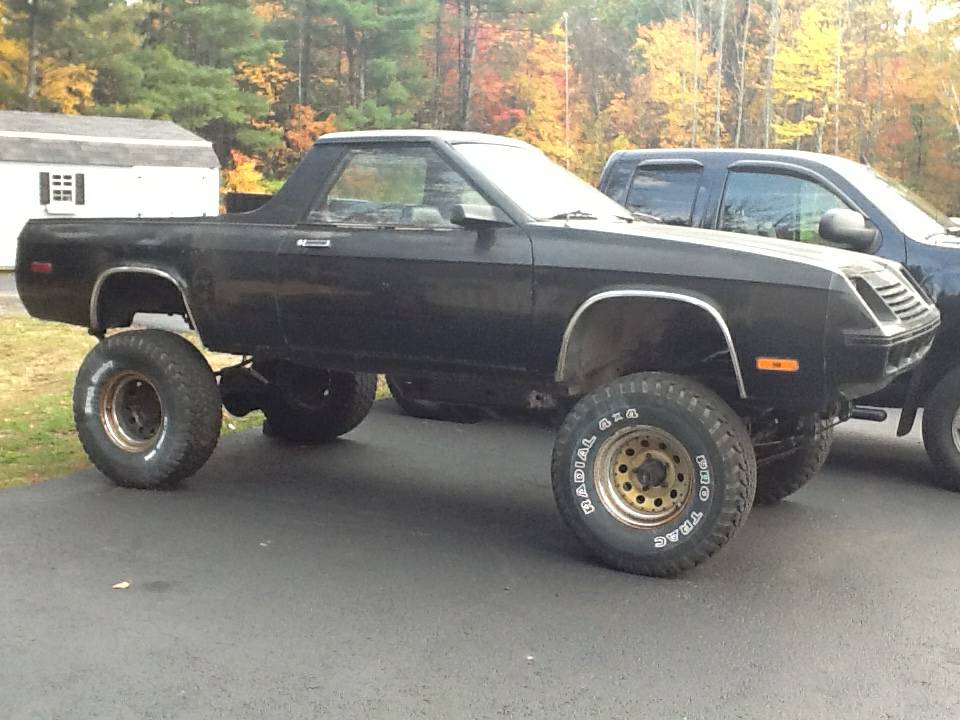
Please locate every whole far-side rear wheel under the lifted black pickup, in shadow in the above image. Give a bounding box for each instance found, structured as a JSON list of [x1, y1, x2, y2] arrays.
[[256, 363, 377, 444]]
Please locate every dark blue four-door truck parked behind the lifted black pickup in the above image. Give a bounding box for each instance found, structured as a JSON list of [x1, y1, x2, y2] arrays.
[[600, 149, 960, 489]]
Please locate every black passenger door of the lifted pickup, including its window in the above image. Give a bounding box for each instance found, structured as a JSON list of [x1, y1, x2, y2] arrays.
[[278, 143, 533, 369]]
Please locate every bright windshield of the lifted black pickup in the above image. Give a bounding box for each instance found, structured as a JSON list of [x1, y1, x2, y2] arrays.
[[454, 143, 632, 221]]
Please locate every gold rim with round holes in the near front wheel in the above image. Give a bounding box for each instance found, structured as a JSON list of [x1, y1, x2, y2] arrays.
[[594, 425, 695, 528]]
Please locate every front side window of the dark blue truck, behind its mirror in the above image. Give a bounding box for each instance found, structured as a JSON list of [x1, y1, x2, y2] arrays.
[[720, 171, 847, 245]]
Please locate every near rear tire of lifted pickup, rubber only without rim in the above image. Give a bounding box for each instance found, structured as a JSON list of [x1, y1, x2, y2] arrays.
[[73, 330, 222, 490]]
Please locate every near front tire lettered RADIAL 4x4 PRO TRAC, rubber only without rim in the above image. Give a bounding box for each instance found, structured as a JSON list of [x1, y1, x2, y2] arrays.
[[552, 373, 757, 577]]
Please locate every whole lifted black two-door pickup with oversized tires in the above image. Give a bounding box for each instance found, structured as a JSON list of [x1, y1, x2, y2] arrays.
[[17, 131, 939, 575]]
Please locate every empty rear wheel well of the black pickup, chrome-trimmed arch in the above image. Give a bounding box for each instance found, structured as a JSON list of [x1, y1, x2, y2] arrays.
[[90, 271, 193, 330]]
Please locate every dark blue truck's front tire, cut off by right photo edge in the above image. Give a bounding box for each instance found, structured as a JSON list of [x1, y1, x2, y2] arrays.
[[922, 368, 960, 490]]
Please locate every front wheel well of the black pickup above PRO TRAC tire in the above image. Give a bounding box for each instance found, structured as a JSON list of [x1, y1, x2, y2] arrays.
[[556, 297, 745, 397]]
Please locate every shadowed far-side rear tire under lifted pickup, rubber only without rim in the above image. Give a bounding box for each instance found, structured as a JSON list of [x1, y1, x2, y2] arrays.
[[263, 372, 377, 445]]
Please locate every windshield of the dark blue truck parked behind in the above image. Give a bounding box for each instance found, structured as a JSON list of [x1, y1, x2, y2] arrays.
[[849, 163, 956, 240]]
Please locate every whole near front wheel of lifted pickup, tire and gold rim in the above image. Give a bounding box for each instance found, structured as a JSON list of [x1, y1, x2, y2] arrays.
[[552, 373, 757, 577]]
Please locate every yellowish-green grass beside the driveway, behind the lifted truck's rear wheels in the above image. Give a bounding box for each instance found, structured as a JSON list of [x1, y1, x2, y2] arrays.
[[0, 316, 389, 488]]
